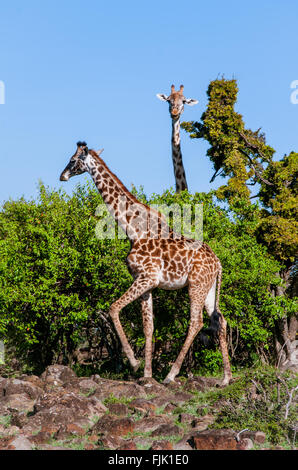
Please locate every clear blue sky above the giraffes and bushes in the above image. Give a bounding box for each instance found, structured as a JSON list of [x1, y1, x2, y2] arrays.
[[0, 0, 298, 201]]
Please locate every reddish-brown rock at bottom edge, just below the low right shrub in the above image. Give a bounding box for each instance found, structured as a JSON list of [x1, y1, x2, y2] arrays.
[[191, 429, 237, 450]]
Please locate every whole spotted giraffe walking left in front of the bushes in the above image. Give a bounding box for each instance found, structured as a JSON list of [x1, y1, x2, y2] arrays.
[[60, 141, 232, 385]]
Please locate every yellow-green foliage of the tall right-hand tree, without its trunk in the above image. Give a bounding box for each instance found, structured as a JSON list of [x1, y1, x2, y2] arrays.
[[182, 78, 298, 266]]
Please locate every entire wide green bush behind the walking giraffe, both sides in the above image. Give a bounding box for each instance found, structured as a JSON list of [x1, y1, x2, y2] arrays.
[[0, 184, 288, 376]]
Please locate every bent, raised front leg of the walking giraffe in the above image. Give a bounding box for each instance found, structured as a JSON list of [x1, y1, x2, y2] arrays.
[[109, 277, 156, 371]]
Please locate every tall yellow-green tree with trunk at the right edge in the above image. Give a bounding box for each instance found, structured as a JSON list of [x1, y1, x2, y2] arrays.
[[182, 78, 298, 365]]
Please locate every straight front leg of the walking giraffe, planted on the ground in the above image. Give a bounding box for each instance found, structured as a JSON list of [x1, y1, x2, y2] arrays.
[[141, 292, 153, 377]]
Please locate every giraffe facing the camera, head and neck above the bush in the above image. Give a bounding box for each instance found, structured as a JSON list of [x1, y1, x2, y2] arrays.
[[156, 85, 198, 193]]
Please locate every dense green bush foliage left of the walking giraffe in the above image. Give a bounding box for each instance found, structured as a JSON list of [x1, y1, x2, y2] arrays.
[[0, 185, 131, 369]]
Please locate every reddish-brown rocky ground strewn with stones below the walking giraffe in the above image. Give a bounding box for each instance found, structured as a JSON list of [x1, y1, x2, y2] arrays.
[[0, 365, 280, 450]]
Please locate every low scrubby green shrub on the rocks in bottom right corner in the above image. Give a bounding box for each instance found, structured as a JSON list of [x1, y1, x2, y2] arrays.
[[209, 366, 298, 444]]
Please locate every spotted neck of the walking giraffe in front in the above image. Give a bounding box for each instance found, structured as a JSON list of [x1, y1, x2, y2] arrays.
[[87, 150, 172, 242]]
